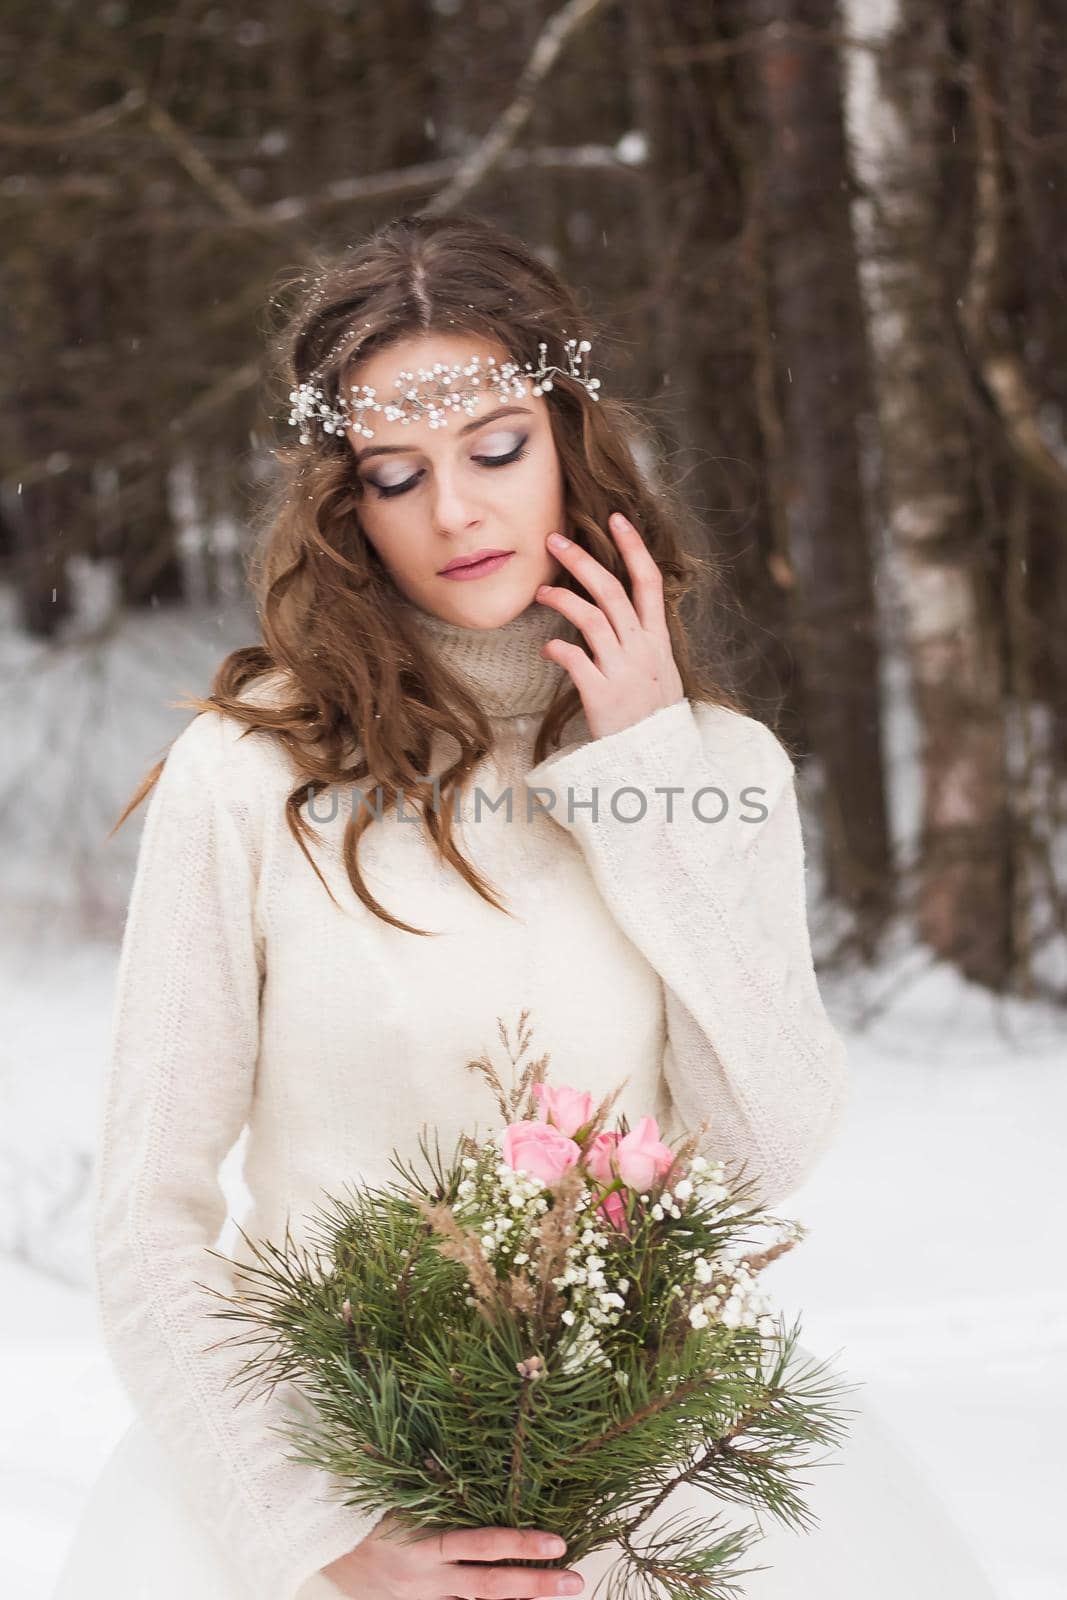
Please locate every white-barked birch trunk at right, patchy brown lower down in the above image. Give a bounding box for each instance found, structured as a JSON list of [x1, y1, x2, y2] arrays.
[[867, 0, 1011, 987]]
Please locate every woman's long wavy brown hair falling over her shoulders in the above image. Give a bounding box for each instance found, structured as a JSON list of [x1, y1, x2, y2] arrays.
[[112, 213, 742, 934]]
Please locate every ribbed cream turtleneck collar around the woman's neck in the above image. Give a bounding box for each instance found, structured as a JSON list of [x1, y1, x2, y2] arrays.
[[399, 600, 584, 717]]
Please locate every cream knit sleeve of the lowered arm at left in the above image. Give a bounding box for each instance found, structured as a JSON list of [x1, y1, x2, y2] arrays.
[[93, 712, 379, 1600]]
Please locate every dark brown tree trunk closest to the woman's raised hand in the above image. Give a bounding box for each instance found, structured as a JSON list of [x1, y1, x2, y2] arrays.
[[638, 0, 793, 731]]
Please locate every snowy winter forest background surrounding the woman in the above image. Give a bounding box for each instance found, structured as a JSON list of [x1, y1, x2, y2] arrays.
[[0, 0, 1067, 1600]]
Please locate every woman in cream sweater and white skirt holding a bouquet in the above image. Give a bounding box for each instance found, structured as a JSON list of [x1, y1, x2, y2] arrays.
[[49, 216, 1004, 1600]]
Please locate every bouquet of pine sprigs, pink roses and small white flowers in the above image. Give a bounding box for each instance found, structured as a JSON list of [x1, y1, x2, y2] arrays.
[[202, 1011, 856, 1600]]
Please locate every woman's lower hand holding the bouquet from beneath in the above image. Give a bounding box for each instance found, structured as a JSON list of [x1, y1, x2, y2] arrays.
[[323, 1512, 584, 1600]]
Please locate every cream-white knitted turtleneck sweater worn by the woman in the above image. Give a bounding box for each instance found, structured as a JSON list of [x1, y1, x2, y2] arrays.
[[94, 602, 849, 1600]]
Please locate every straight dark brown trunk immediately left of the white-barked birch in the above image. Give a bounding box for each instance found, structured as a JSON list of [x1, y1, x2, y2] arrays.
[[742, 0, 894, 934]]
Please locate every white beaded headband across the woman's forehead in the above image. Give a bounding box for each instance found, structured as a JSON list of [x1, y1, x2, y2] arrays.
[[290, 339, 600, 445]]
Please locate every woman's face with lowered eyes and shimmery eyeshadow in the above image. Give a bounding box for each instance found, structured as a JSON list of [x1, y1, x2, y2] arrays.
[[344, 333, 566, 629]]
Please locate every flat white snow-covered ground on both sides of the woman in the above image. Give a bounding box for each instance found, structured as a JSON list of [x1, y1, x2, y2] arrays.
[[0, 921, 1067, 1600]]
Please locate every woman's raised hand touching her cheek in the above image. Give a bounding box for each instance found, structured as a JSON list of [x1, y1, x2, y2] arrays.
[[534, 512, 685, 739]]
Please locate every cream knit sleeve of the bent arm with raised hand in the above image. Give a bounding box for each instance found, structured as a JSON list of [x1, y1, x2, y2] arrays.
[[526, 699, 849, 1205]]
